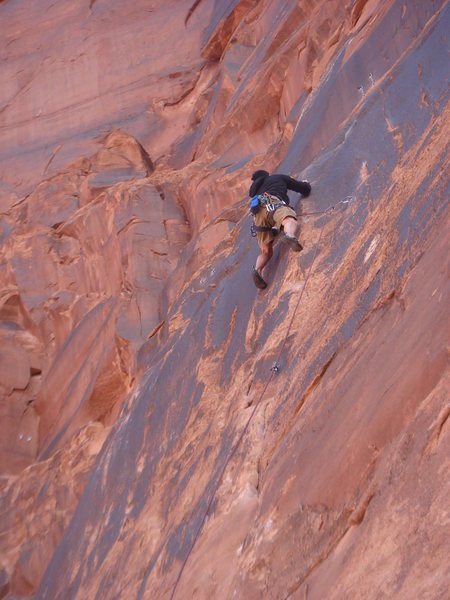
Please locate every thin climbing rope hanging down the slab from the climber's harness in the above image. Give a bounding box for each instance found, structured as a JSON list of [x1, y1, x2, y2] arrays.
[[170, 196, 354, 600]]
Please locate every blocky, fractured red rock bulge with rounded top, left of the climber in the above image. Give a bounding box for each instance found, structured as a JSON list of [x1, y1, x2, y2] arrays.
[[2, 132, 189, 472]]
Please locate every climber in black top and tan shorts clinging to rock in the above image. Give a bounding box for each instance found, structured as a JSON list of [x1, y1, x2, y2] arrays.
[[248, 170, 311, 290]]
